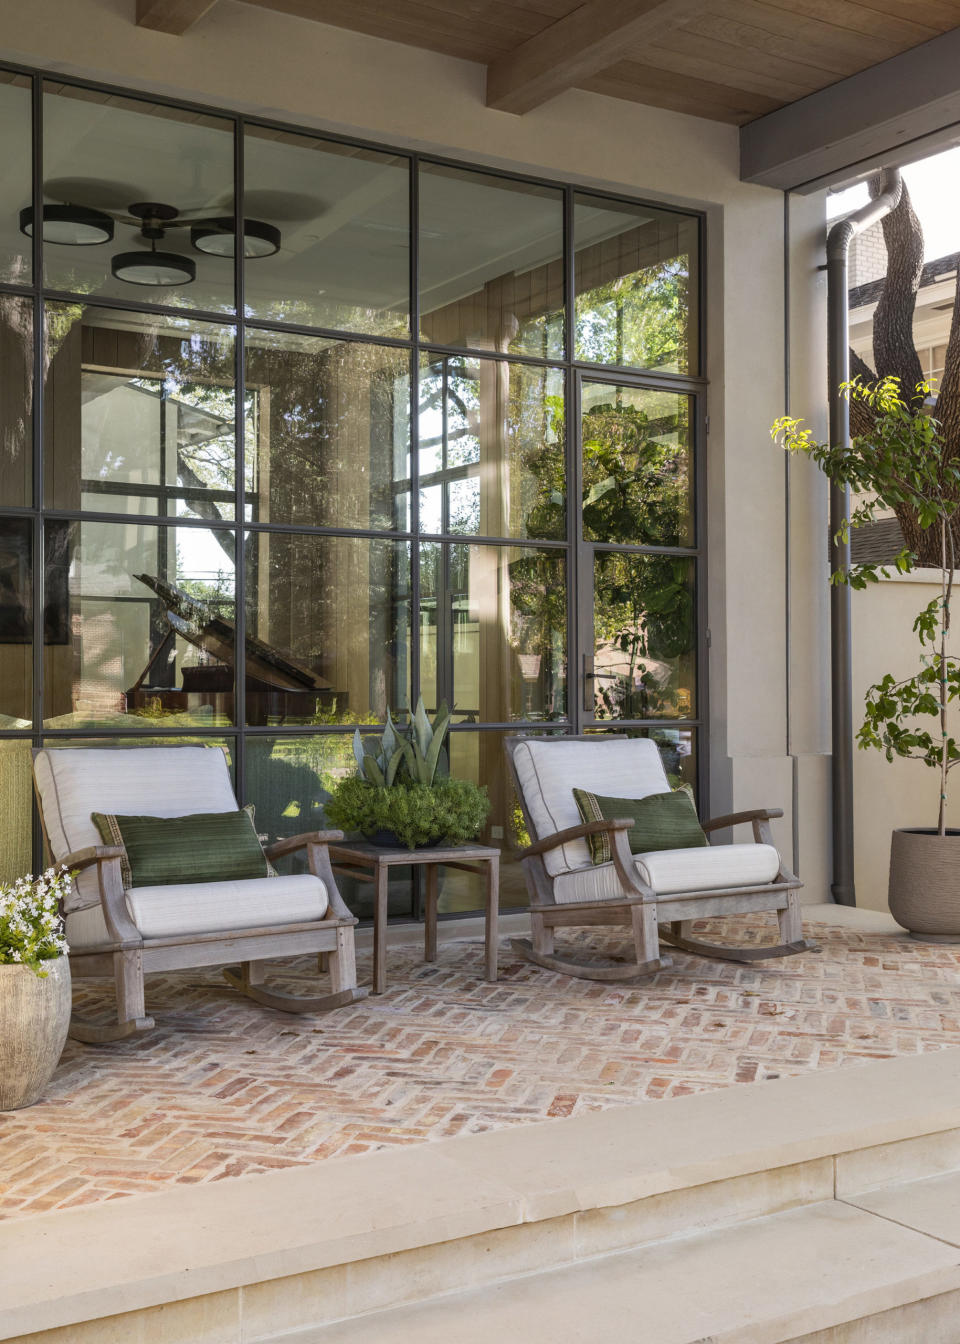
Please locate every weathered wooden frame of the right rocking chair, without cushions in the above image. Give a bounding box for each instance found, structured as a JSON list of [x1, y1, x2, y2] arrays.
[[504, 734, 812, 981]]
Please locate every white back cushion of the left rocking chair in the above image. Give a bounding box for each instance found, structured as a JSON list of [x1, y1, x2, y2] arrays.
[[34, 746, 238, 910]]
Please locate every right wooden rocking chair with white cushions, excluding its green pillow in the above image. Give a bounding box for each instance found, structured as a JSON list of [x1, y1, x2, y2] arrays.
[[506, 737, 812, 981]]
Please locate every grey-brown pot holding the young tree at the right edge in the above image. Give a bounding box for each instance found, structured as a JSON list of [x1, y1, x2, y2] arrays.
[[889, 829, 960, 942]]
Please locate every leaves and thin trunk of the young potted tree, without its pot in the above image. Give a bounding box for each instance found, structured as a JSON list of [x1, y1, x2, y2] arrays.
[[772, 378, 960, 833]]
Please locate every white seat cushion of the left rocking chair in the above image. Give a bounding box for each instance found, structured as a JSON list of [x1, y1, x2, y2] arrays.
[[67, 872, 328, 952]]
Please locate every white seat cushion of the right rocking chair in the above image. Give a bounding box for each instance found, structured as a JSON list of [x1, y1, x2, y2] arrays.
[[554, 844, 780, 905]]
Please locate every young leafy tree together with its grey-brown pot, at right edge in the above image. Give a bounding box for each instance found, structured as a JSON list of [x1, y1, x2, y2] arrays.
[[772, 376, 960, 942]]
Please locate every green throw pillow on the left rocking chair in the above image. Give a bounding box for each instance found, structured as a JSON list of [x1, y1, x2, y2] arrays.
[[91, 806, 274, 888]]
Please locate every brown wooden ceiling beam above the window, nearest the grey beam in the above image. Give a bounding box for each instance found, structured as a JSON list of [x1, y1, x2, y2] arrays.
[[487, 0, 705, 114]]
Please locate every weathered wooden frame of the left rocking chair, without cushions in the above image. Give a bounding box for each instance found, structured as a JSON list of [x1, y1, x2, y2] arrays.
[[34, 750, 367, 1044]]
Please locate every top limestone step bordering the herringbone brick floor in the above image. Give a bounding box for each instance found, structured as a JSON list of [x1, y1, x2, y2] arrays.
[[0, 1050, 960, 1340]]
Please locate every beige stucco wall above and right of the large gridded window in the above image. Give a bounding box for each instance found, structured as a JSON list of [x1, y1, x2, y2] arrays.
[[0, 0, 828, 900]]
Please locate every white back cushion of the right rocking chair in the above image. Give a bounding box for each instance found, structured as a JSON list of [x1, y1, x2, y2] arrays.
[[514, 738, 670, 876]]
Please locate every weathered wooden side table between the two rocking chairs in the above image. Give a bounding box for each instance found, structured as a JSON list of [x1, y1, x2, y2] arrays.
[[329, 840, 500, 995]]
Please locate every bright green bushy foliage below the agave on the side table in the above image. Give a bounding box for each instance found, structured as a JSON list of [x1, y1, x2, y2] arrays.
[[325, 775, 489, 849]]
